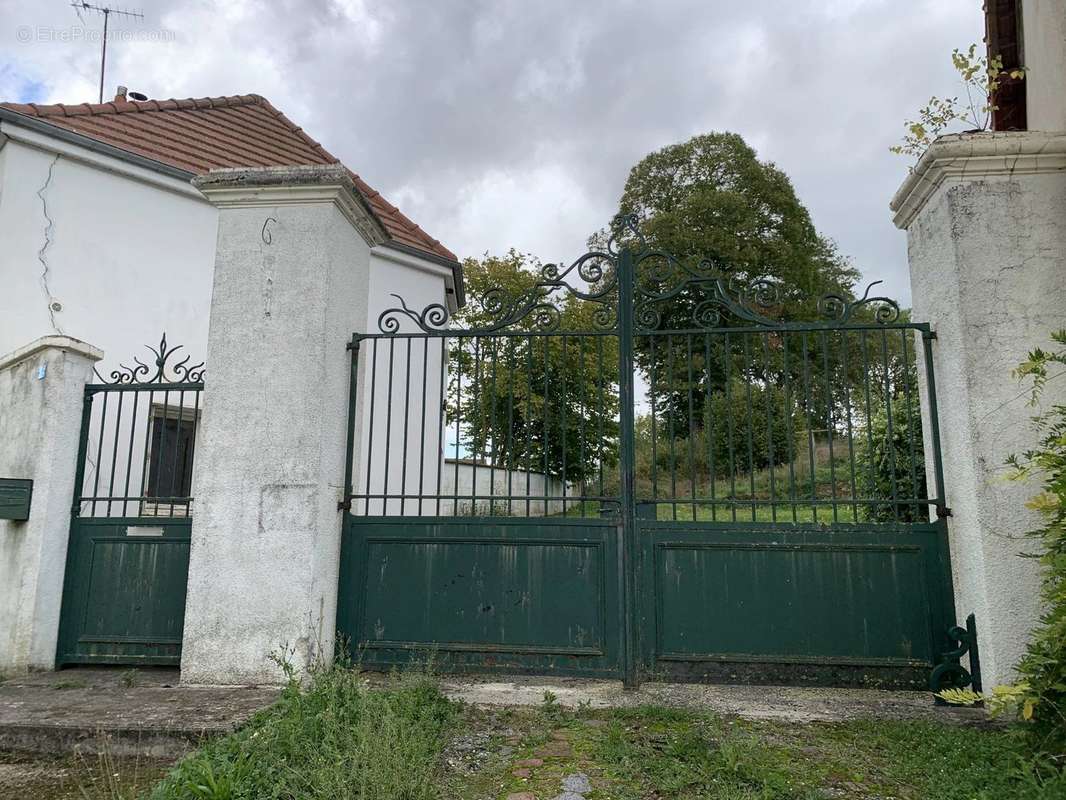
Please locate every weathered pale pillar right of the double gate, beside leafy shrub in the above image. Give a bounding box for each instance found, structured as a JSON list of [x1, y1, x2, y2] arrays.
[[891, 131, 1066, 687]]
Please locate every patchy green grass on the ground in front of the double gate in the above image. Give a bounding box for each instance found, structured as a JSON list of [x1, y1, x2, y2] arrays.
[[68, 670, 1066, 800]]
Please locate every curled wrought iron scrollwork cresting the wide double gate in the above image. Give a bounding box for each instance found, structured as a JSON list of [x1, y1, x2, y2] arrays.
[[377, 214, 900, 335]]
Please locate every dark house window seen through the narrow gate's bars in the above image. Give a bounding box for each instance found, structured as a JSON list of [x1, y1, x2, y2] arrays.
[[142, 404, 199, 516]]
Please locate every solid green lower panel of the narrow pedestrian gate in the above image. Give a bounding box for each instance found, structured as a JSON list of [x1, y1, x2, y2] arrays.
[[56, 517, 192, 665]]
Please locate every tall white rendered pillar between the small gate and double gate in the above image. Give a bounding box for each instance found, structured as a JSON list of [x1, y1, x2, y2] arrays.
[[181, 165, 384, 684]]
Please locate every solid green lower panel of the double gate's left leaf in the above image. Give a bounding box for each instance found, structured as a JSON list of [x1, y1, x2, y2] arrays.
[[338, 515, 620, 675]]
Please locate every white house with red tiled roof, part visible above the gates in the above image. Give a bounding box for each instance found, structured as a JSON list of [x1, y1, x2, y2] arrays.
[[0, 90, 463, 375]]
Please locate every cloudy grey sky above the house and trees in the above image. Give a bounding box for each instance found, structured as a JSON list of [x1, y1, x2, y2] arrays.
[[0, 0, 982, 301]]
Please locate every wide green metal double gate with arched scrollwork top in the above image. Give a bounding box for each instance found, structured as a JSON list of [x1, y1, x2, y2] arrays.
[[338, 218, 955, 686]]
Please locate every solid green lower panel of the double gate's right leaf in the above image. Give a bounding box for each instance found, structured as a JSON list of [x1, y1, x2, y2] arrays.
[[639, 519, 953, 685]]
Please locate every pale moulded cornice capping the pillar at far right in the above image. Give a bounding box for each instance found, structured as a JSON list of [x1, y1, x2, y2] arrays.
[[889, 131, 1066, 229]]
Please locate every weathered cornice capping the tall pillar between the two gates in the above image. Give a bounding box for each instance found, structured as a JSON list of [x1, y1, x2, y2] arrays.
[[193, 164, 388, 247]]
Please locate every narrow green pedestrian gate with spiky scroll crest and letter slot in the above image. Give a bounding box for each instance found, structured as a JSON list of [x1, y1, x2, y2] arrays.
[[56, 335, 204, 666]]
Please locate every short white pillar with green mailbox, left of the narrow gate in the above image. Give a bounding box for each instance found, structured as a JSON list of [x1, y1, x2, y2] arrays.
[[0, 336, 103, 671]]
